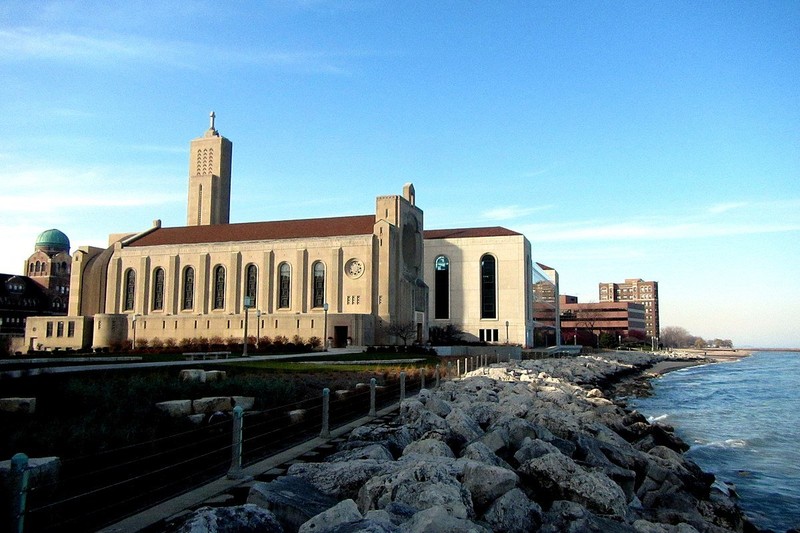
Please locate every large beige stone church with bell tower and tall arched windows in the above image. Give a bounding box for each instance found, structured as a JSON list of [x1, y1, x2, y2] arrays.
[[25, 113, 533, 350]]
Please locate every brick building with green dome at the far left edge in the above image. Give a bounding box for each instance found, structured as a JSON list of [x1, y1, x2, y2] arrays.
[[0, 229, 72, 351]]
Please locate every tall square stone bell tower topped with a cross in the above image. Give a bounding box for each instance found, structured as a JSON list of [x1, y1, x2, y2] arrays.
[[186, 111, 233, 226]]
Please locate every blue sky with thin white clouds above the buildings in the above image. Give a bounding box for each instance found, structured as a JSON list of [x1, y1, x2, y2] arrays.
[[0, 0, 800, 347]]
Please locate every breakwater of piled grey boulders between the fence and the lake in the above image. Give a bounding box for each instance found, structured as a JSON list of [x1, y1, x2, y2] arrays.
[[172, 353, 756, 533]]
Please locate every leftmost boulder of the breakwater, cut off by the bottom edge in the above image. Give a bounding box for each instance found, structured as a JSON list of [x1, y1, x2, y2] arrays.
[[174, 504, 284, 533]]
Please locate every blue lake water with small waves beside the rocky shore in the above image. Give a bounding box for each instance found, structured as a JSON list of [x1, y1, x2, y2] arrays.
[[628, 352, 800, 532]]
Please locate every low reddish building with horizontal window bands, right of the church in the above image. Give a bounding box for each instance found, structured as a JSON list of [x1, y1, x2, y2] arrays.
[[560, 295, 645, 345]]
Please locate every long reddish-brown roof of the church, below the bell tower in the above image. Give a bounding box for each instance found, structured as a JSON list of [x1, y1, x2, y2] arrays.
[[128, 215, 375, 246]]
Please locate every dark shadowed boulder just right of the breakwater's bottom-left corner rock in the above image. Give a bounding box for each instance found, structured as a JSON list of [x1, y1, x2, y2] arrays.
[[247, 476, 338, 531]]
